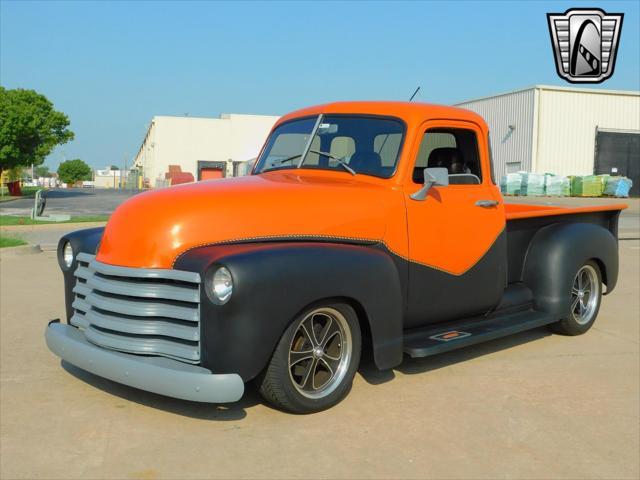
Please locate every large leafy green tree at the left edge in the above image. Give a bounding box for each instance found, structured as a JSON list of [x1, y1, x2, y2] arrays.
[[0, 87, 73, 173]]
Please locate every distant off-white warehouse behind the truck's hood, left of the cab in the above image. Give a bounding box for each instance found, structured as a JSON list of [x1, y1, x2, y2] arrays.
[[134, 114, 280, 187]]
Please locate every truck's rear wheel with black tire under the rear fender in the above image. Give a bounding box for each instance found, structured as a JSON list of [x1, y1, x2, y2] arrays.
[[551, 260, 602, 336]]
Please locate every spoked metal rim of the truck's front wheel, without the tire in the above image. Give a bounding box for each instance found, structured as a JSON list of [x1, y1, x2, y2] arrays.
[[289, 307, 353, 398]]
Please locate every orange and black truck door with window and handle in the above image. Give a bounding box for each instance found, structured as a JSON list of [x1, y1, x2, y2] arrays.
[[405, 121, 506, 328]]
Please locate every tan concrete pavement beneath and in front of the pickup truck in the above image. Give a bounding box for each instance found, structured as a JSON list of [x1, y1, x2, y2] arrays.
[[0, 244, 640, 479]]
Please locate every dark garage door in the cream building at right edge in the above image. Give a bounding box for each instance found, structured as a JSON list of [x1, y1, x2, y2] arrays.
[[594, 132, 640, 197]]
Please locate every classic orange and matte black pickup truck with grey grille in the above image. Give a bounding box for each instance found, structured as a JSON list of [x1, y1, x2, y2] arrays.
[[46, 102, 625, 412]]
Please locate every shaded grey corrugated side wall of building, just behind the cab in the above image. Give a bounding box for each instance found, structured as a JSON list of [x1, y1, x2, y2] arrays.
[[457, 88, 535, 180]]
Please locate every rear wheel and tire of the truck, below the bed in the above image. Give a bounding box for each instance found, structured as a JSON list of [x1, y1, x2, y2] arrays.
[[553, 261, 602, 335]]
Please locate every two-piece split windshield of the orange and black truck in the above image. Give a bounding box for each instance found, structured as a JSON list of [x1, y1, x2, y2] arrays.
[[255, 115, 404, 178]]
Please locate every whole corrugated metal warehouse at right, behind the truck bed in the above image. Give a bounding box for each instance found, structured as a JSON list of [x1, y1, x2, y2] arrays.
[[457, 85, 640, 195]]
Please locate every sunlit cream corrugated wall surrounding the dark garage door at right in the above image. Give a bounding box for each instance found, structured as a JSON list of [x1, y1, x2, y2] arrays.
[[533, 87, 640, 175]]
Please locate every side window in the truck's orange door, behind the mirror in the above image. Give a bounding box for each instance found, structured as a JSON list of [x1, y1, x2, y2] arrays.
[[413, 128, 482, 185]]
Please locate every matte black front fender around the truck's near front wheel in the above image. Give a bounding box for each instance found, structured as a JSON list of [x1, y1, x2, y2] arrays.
[[174, 242, 404, 381]]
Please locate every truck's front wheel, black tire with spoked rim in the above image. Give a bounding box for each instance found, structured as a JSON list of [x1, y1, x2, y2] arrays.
[[256, 303, 362, 413]]
